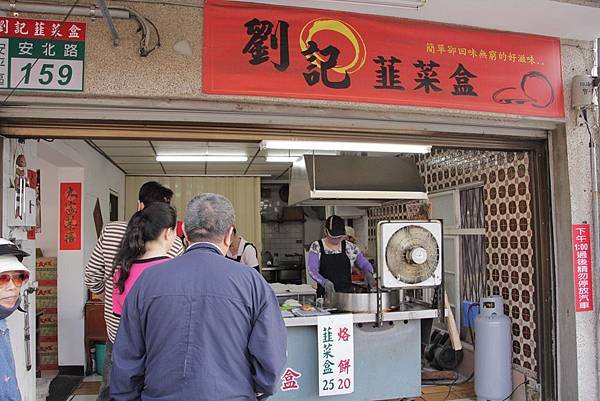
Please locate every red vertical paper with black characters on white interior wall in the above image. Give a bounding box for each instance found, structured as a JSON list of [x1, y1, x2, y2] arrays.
[[59, 182, 82, 251]]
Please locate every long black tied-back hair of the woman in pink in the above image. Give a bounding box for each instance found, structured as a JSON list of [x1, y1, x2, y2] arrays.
[[112, 202, 177, 293]]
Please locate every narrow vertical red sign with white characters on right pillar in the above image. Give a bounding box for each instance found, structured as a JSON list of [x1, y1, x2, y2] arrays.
[[573, 224, 594, 312]]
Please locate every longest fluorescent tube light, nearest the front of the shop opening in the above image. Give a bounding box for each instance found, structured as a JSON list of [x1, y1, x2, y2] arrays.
[[260, 140, 431, 153]]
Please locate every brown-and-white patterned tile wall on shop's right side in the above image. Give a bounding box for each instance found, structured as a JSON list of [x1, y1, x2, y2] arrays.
[[369, 149, 538, 379]]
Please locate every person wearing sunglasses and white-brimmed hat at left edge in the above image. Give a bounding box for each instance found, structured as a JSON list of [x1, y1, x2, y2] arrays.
[[0, 238, 29, 401]]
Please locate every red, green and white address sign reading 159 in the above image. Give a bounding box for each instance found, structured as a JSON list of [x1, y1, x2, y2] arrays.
[[0, 17, 86, 91]]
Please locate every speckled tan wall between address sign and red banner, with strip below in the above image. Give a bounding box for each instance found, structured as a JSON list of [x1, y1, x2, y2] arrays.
[[5, 1, 580, 121]]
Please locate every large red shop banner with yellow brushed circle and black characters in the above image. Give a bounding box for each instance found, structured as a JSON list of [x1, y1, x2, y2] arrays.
[[202, 0, 564, 118]]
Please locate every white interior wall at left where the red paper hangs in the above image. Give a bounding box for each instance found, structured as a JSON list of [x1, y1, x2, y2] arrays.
[[29, 140, 125, 366]]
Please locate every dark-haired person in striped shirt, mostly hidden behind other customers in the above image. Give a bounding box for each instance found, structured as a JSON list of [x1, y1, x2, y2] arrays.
[[85, 181, 184, 401]]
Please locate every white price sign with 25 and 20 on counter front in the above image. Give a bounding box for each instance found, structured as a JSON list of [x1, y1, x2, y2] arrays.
[[317, 314, 354, 397]]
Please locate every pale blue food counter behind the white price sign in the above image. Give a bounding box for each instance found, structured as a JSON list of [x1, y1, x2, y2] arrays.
[[269, 309, 438, 401]]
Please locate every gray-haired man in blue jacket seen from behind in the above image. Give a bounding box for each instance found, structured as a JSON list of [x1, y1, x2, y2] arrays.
[[111, 194, 287, 401]]
